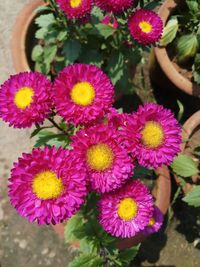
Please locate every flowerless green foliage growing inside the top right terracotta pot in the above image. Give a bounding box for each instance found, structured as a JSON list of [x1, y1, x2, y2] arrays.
[[160, 0, 200, 84]]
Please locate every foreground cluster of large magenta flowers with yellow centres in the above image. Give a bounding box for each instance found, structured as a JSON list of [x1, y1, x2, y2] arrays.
[[0, 64, 181, 238]]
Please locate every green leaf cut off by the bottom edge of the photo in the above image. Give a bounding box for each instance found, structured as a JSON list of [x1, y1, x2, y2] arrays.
[[68, 253, 103, 267]]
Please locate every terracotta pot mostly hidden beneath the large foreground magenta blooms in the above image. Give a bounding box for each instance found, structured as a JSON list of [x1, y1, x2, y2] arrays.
[[53, 166, 171, 250]]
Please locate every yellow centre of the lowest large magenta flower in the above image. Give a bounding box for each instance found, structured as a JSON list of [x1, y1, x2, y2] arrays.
[[117, 197, 138, 221]]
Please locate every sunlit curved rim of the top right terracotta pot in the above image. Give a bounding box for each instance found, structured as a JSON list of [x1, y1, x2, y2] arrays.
[[154, 0, 200, 97]]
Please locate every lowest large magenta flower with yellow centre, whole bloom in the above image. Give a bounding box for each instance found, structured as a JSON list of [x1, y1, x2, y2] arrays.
[[99, 180, 153, 238]]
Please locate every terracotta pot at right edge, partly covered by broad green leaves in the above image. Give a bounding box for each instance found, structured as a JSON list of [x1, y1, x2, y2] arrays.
[[175, 110, 200, 193]]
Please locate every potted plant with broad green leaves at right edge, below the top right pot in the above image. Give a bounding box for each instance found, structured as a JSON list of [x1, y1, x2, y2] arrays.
[[171, 111, 200, 207]]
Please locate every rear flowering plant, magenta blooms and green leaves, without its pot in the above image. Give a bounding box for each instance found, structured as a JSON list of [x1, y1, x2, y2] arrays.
[[32, 0, 162, 93]]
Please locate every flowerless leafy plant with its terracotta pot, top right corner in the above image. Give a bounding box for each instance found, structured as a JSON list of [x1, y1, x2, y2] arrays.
[[150, 0, 200, 97]]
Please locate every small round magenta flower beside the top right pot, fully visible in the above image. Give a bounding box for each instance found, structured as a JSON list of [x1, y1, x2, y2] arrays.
[[128, 9, 163, 45]]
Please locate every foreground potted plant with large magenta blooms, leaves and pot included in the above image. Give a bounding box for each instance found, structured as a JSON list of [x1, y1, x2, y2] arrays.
[[0, 57, 181, 266]]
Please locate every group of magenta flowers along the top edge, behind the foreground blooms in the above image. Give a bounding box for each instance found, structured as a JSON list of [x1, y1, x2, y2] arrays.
[[54, 0, 163, 45]]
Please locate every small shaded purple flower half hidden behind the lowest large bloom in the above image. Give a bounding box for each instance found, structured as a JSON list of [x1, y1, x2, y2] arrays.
[[144, 206, 163, 235]]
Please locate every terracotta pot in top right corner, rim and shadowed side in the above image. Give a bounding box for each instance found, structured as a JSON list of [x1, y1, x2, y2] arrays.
[[150, 0, 200, 97]]
